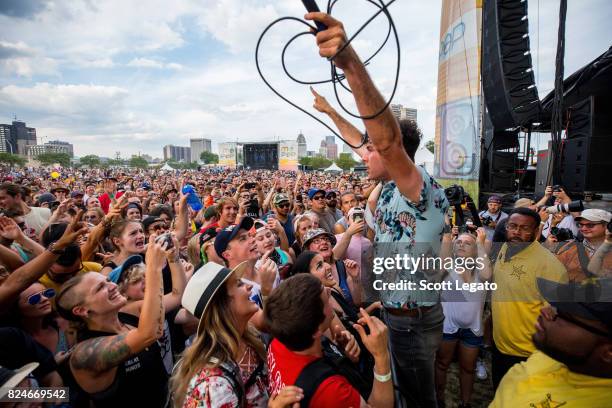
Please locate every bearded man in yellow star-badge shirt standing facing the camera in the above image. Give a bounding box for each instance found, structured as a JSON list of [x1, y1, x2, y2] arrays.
[[491, 208, 567, 388]]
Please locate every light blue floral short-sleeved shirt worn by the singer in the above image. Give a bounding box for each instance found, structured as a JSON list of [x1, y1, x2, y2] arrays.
[[374, 166, 449, 308]]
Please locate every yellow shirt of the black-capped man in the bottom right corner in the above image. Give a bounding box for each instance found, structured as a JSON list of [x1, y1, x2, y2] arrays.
[[489, 351, 612, 408]]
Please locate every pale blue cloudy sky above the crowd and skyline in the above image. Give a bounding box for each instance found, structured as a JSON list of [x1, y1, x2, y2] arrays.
[[0, 0, 612, 157]]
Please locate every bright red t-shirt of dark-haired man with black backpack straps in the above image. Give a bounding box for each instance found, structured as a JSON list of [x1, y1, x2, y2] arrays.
[[268, 339, 361, 408]]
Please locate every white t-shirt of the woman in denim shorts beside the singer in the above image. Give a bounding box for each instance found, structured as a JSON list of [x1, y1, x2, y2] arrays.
[[440, 270, 486, 336]]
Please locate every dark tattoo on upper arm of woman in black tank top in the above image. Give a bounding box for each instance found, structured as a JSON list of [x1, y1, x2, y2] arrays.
[[70, 333, 132, 373]]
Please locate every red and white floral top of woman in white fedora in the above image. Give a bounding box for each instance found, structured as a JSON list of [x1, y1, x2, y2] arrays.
[[183, 349, 268, 408]]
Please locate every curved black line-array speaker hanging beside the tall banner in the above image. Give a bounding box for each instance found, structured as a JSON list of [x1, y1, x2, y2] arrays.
[[481, 0, 542, 130]]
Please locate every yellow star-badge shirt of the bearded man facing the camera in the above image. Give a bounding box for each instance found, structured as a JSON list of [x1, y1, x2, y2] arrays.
[[491, 242, 567, 357]]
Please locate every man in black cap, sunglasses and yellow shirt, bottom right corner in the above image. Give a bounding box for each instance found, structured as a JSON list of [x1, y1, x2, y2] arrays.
[[489, 278, 612, 408]]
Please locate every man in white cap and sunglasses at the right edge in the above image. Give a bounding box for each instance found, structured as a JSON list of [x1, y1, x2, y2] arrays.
[[557, 208, 612, 282]]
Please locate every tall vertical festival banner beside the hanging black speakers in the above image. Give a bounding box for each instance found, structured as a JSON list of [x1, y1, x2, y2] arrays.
[[434, 0, 482, 200]]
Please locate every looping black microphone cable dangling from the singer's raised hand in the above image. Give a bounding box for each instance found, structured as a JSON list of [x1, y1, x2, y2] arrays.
[[255, 0, 401, 149]]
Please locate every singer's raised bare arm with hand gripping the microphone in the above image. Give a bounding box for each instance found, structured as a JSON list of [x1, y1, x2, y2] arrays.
[[305, 13, 423, 202]]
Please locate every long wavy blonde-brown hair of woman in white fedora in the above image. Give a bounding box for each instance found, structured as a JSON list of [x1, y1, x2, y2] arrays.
[[170, 283, 266, 407]]
